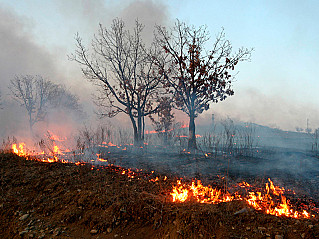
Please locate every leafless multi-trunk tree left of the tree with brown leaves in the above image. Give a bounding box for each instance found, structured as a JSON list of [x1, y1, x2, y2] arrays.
[[70, 19, 162, 146]]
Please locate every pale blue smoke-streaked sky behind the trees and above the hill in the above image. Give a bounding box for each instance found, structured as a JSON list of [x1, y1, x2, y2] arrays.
[[0, 0, 319, 130]]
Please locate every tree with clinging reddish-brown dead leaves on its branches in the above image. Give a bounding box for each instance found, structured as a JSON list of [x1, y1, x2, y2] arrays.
[[156, 20, 252, 149]]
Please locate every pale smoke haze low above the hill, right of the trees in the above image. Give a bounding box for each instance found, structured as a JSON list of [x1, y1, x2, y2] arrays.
[[198, 89, 319, 131]]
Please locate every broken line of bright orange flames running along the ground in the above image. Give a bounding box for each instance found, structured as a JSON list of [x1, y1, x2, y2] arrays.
[[8, 136, 314, 218]]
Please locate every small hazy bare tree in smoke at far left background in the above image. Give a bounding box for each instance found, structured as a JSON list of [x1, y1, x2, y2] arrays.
[[9, 75, 80, 132]]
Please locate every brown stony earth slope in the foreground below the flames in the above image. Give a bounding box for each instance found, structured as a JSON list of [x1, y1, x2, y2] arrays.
[[0, 154, 319, 239]]
